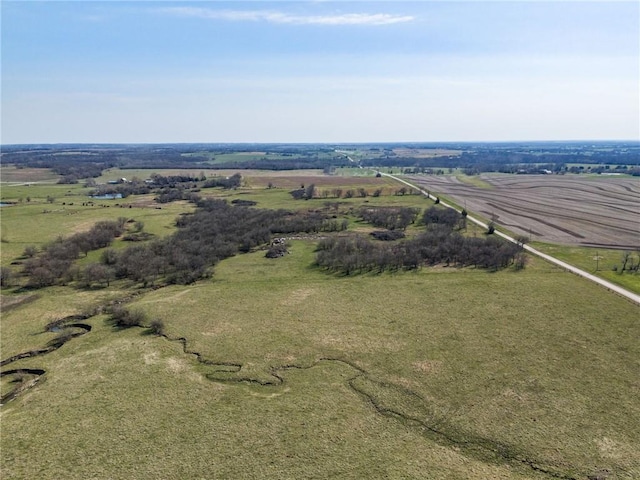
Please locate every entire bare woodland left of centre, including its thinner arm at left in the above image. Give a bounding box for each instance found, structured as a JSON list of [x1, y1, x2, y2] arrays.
[[18, 199, 348, 288]]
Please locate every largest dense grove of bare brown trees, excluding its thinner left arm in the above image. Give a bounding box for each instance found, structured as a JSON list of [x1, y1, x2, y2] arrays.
[[95, 199, 346, 286]]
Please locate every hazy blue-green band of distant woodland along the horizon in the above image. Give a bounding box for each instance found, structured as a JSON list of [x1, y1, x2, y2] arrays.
[[2, 142, 640, 183]]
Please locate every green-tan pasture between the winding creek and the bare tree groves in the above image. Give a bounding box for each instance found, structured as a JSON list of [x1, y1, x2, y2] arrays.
[[122, 246, 640, 478]]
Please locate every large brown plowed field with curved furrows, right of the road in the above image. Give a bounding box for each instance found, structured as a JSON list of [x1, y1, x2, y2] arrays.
[[408, 175, 640, 248]]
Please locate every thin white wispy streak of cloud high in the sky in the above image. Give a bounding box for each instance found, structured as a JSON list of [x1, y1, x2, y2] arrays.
[[161, 7, 415, 26]]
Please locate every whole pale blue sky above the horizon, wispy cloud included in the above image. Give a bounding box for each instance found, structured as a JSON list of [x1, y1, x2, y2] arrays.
[[1, 0, 640, 144]]
